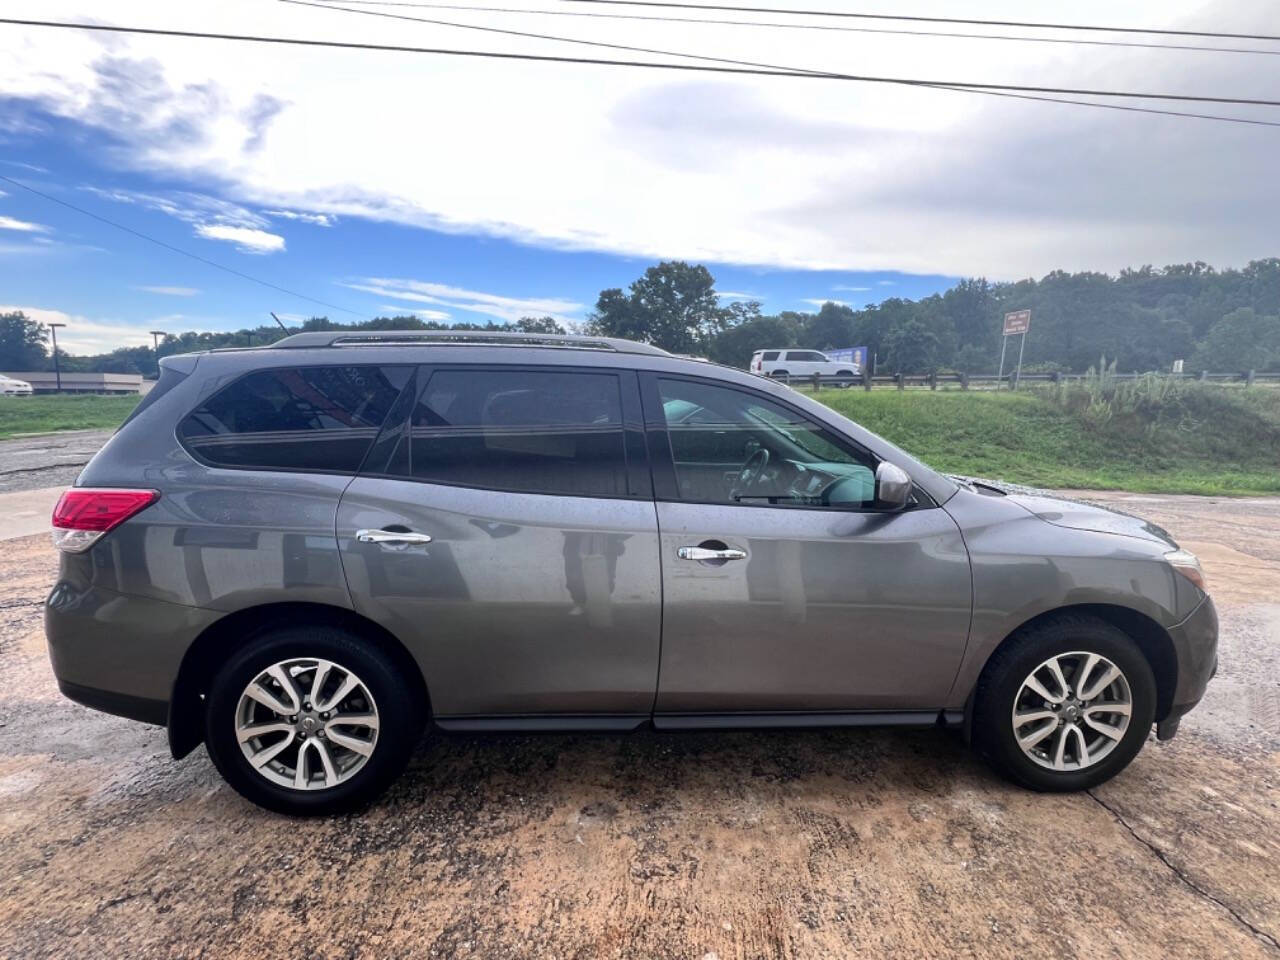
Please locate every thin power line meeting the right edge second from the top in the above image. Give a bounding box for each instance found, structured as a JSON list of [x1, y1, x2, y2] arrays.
[[307, 0, 1280, 56]]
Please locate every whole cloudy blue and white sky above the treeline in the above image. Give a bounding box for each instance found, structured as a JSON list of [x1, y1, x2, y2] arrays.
[[0, 0, 1280, 353]]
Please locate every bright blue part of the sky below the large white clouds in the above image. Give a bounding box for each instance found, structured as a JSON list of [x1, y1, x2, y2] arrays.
[[0, 111, 955, 352]]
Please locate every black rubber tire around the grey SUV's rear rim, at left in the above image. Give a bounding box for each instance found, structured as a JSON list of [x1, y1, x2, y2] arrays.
[[205, 626, 426, 817]]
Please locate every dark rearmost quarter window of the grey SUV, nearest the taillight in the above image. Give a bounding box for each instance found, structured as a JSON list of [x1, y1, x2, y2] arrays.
[[178, 366, 412, 474]]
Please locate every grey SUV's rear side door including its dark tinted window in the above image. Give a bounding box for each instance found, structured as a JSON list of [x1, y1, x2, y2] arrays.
[[338, 366, 660, 726]]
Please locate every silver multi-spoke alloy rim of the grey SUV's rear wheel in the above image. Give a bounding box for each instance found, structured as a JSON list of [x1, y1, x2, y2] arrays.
[[236, 657, 379, 791]]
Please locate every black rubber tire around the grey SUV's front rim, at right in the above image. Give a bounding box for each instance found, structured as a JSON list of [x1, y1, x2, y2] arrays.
[[973, 616, 1156, 792]]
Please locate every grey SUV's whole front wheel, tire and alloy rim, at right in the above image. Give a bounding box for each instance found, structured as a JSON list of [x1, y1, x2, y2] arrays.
[[973, 617, 1156, 791]]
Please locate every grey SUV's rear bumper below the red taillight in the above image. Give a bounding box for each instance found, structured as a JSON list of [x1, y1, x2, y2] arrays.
[[45, 579, 221, 724]]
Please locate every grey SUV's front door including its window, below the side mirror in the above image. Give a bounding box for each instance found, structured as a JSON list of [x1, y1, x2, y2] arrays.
[[644, 375, 972, 714]]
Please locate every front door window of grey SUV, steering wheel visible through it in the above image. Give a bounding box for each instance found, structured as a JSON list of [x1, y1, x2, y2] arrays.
[[658, 379, 877, 509]]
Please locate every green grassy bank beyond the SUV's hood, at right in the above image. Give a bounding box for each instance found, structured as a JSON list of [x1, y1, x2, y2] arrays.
[[817, 387, 1280, 495]]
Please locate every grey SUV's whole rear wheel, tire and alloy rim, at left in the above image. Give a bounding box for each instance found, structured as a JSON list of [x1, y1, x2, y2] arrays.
[[205, 626, 424, 815]]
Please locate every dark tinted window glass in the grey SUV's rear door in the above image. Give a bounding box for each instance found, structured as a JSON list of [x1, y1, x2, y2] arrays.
[[390, 370, 627, 497]]
